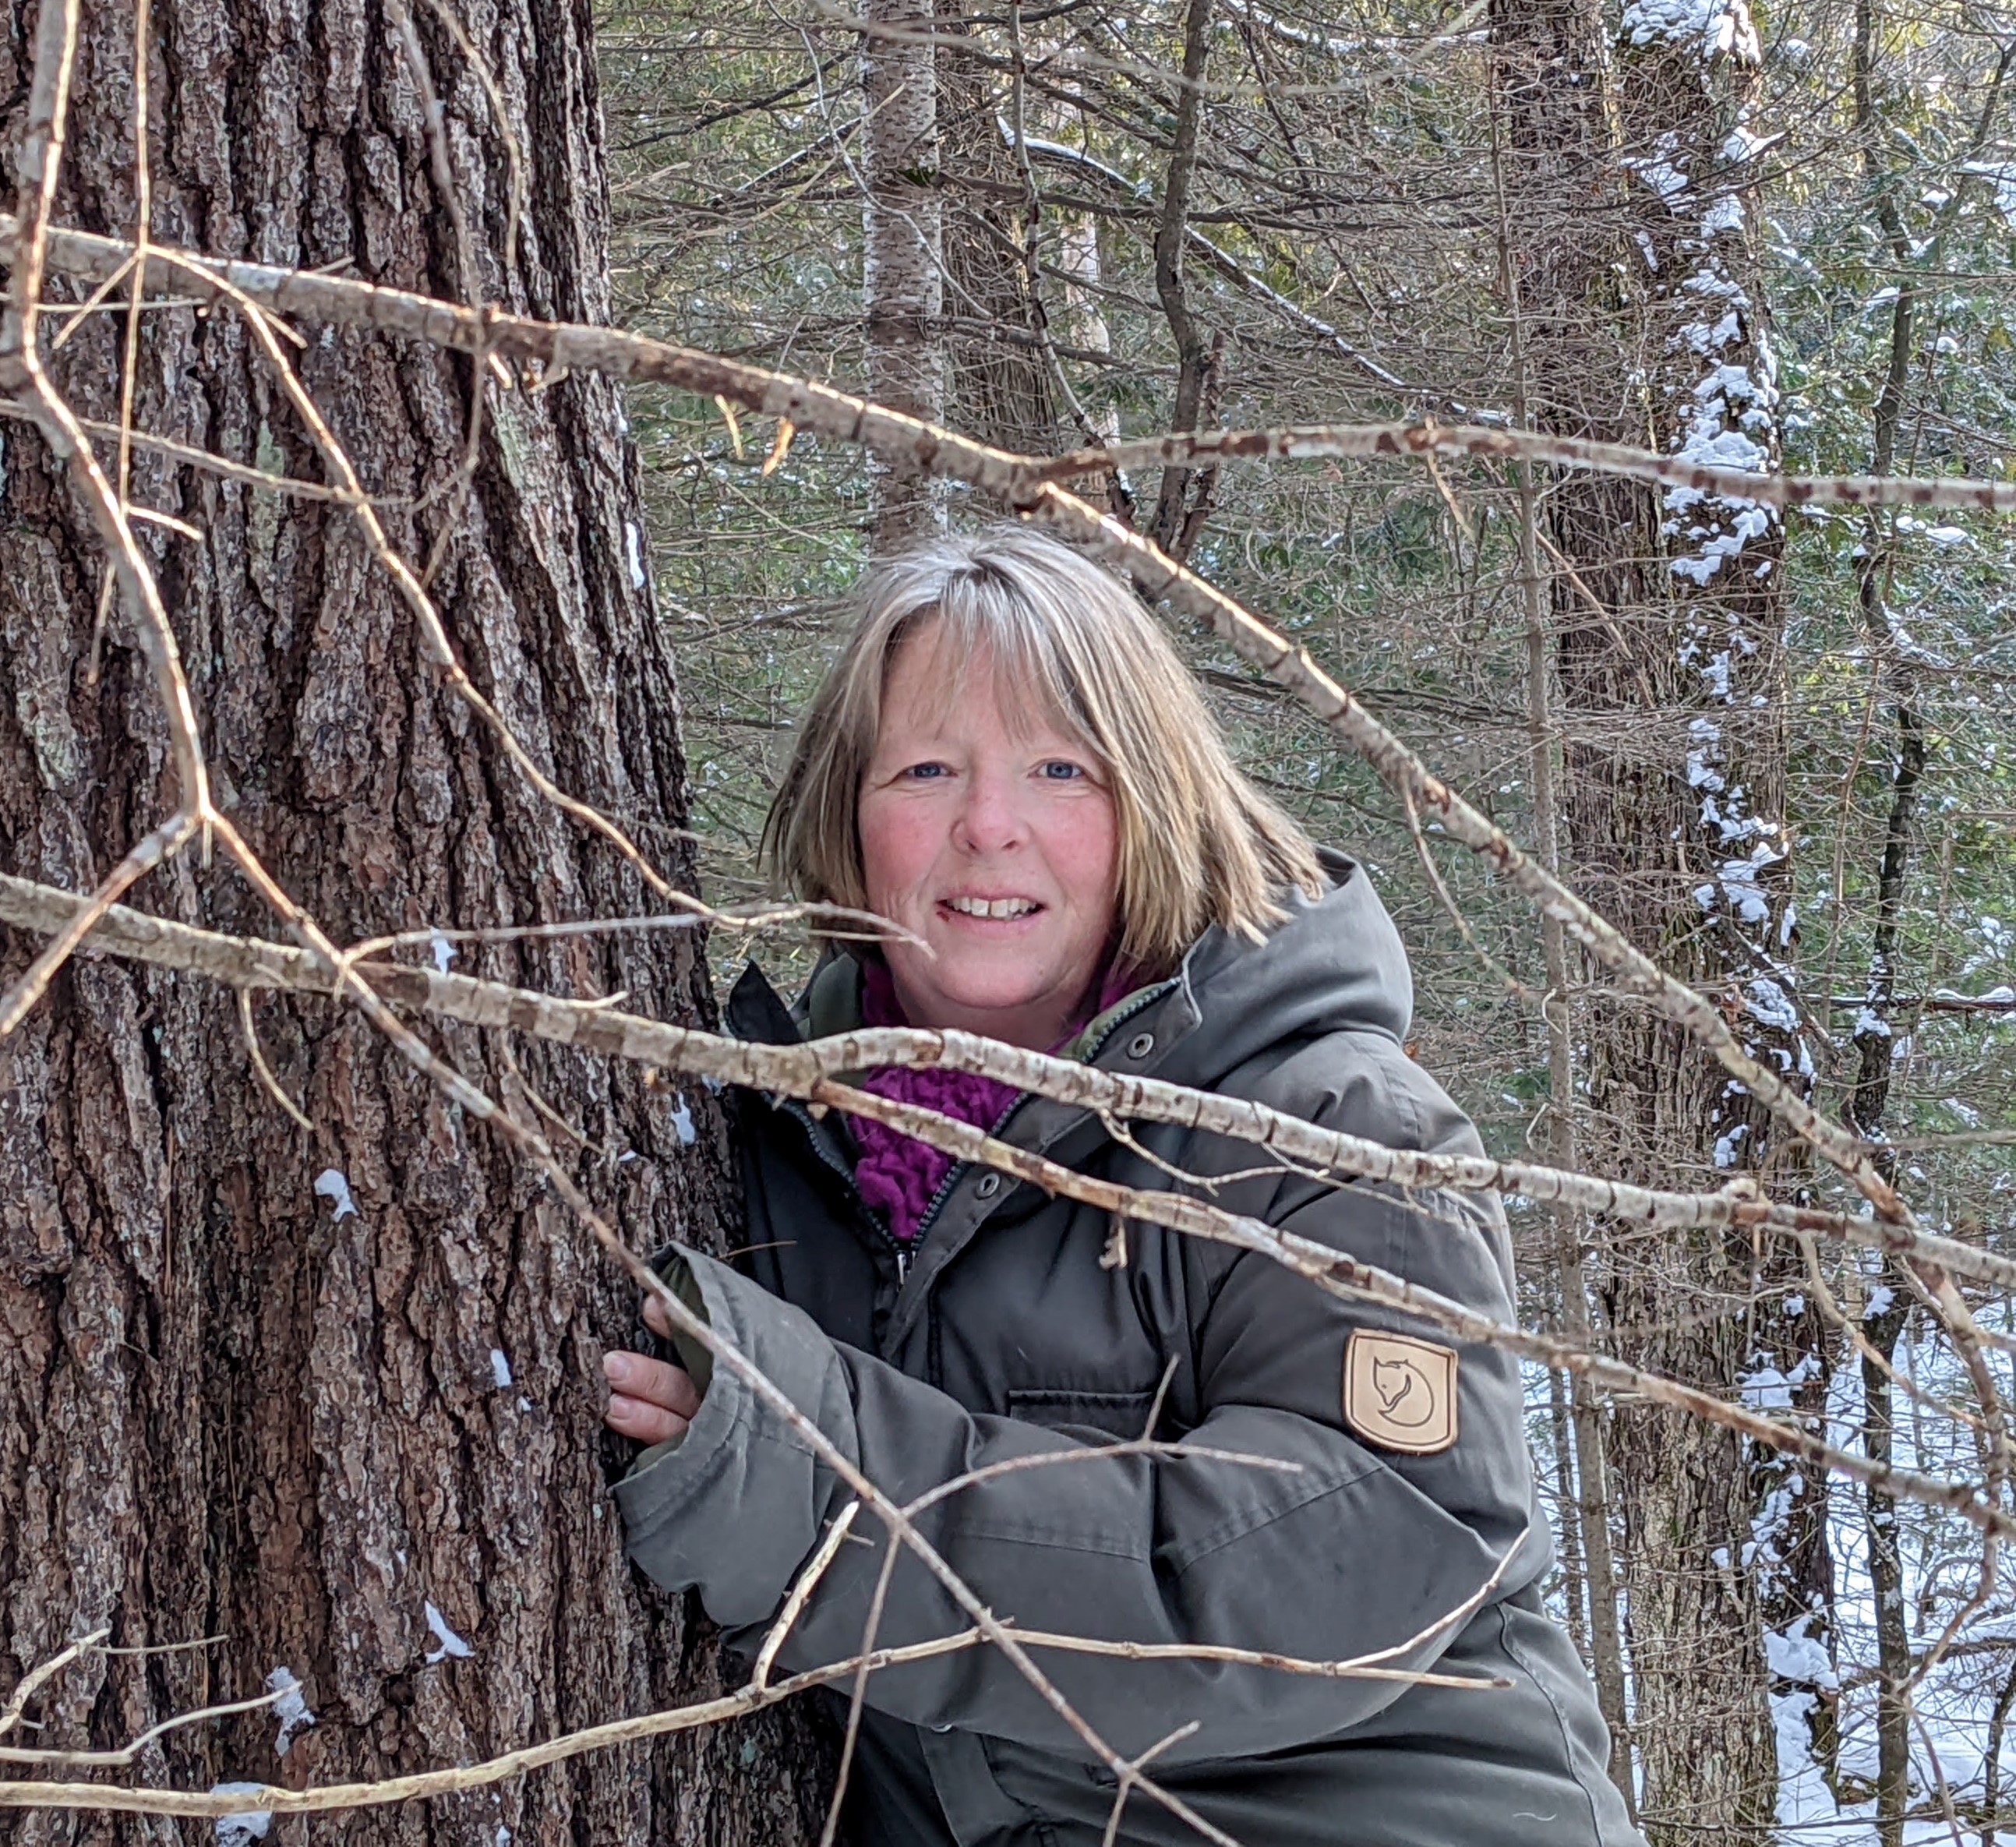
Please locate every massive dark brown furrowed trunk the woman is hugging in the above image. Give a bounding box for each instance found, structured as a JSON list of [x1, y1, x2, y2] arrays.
[[0, 0, 826, 1847]]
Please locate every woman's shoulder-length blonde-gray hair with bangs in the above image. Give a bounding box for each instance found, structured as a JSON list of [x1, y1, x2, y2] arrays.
[[764, 524, 1325, 972]]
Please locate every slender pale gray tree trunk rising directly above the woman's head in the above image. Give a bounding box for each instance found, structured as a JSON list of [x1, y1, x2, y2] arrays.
[[861, 0, 945, 556]]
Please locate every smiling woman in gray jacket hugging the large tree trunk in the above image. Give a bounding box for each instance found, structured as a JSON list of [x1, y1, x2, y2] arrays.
[[607, 528, 1635, 1847]]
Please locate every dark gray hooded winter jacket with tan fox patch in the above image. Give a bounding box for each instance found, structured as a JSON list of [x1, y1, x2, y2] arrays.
[[617, 857, 1637, 1847]]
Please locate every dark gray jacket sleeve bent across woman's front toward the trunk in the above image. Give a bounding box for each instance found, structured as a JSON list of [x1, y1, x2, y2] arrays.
[[617, 1048, 1546, 1762]]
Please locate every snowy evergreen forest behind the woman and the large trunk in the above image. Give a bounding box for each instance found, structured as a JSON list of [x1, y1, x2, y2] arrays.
[[603, 0, 2016, 1841]]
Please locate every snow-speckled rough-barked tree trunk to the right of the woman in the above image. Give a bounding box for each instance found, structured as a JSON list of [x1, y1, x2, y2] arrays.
[[1605, 0, 1833, 1839]]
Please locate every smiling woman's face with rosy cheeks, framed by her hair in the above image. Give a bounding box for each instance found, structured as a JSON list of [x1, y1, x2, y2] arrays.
[[859, 623, 1117, 1051]]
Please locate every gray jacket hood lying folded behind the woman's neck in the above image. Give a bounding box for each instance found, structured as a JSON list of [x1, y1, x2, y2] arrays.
[[1155, 849, 1413, 1089]]
